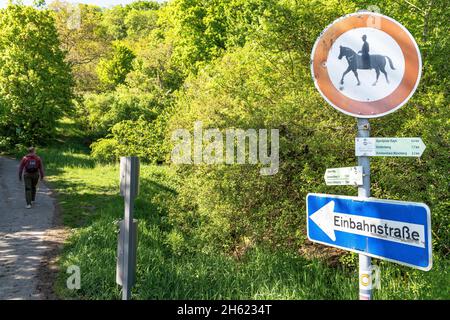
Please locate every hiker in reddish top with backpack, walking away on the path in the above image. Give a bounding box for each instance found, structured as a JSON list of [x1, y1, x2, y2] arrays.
[[19, 147, 44, 209]]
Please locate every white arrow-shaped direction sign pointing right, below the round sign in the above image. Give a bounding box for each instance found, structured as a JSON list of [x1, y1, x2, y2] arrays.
[[355, 138, 426, 157]]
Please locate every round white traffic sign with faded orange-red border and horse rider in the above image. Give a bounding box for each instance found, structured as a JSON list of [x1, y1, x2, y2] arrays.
[[311, 12, 422, 118]]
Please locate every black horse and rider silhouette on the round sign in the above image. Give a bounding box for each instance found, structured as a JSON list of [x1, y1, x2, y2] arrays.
[[338, 35, 395, 86]]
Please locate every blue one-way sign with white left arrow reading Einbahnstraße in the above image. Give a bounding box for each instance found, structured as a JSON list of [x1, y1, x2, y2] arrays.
[[306, 193, 432, 271]]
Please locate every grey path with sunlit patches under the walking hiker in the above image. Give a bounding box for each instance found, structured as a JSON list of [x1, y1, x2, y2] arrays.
[[0, 157, 64, 300]]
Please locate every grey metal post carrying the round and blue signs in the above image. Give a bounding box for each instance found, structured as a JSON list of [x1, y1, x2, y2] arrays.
[[357, 118, 372, 300]]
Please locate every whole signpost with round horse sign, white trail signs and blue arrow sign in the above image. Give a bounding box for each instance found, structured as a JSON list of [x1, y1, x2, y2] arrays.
[[306, 10, 432, 300]]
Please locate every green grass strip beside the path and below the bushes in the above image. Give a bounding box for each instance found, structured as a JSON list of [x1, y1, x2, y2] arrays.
[[24, 119, 450, 299]]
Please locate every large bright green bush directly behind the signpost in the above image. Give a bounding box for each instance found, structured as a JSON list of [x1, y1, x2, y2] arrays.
[[165, 0, 450, 253]]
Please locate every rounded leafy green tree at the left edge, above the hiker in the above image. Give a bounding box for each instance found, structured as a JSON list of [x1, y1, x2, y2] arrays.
[[0, 4, 73, 146]]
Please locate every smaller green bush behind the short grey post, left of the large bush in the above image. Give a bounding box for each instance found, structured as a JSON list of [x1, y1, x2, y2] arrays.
[[78, 74, 172, 163]]
